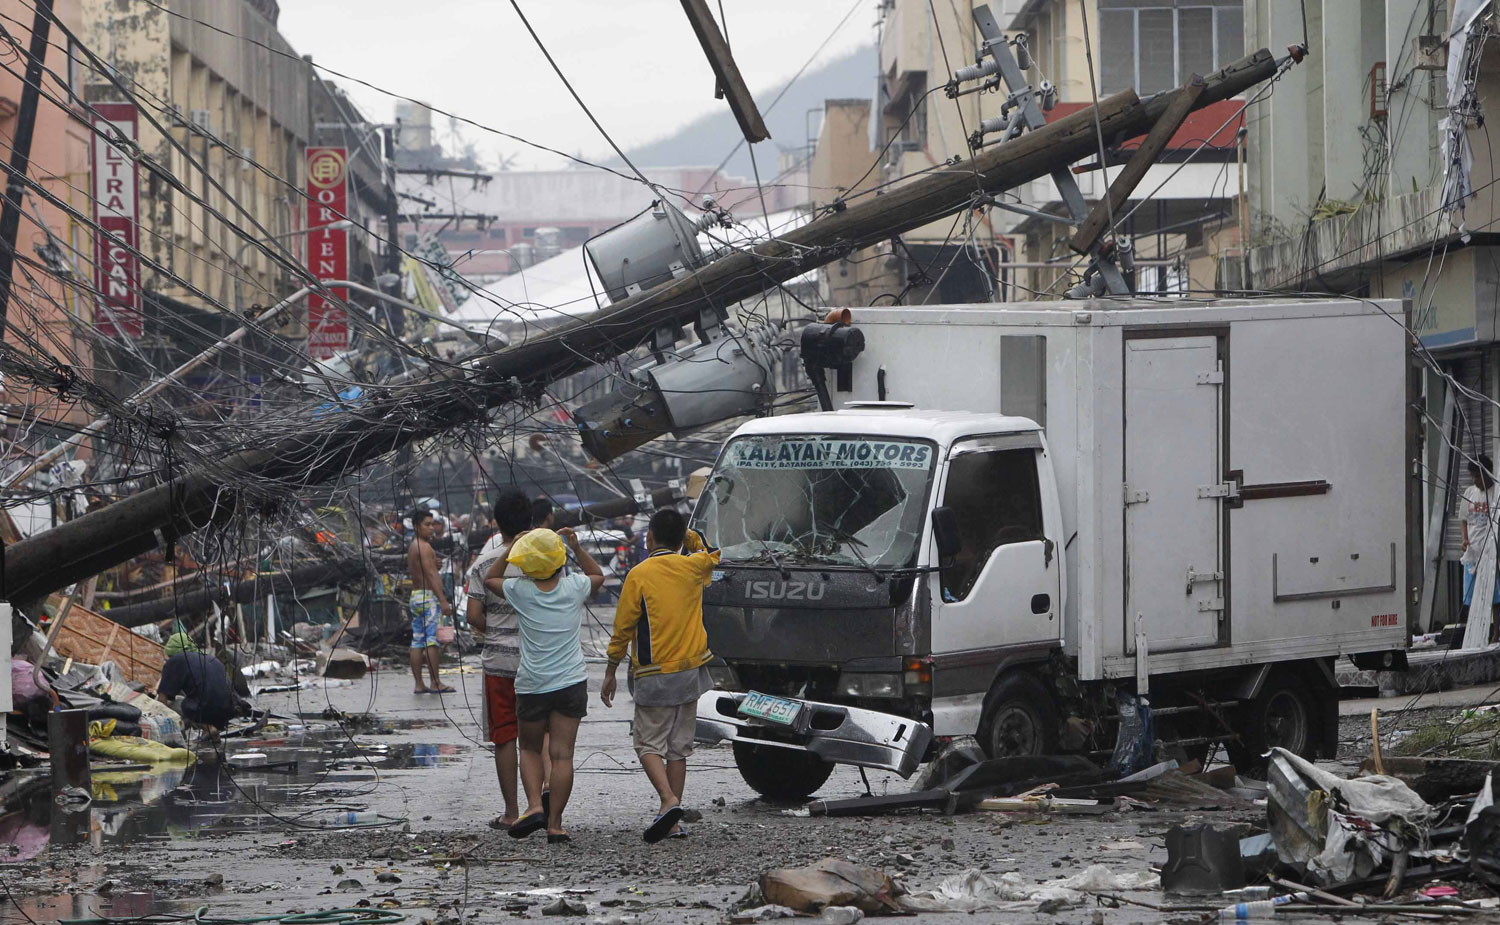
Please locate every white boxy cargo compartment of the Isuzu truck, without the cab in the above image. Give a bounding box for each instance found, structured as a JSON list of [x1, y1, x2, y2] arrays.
[[833, 298, 1421, 681]]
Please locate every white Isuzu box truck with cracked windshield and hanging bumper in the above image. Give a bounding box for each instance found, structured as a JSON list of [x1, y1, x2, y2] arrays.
[[695, 300, 1421, 798]]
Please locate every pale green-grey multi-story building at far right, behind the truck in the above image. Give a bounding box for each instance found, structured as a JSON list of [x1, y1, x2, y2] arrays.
[[1245, 0, 1500, 624]]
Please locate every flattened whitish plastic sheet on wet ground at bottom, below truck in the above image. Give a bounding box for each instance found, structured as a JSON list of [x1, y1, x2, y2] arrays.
[[900, 864, 1161, 912]]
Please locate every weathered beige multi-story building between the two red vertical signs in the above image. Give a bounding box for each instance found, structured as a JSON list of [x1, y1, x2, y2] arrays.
[[83, 0, 314, 316]]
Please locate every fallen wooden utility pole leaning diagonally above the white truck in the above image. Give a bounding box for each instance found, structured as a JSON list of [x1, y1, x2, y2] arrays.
[[0, 49, 1278, 607]]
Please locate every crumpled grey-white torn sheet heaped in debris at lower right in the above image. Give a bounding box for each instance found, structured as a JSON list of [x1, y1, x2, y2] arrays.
[[1268, 748, 1433, 883]]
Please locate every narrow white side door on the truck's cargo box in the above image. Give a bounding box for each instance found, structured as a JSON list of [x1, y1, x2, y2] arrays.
[[1125, 334, 1229, 652]]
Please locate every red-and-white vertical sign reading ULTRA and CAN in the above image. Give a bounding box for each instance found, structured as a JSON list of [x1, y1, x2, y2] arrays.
[[90, 103, 146, 337]]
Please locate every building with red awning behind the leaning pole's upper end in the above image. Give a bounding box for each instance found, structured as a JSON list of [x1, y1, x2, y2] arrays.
[[1010, 0, 1254, 295]]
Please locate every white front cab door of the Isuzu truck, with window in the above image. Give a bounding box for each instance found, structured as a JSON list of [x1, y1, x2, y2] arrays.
[[932, 435, 1062, 656]]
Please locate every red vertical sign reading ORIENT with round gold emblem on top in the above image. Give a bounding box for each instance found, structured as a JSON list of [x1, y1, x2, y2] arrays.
[[308, 148, 350, 360]]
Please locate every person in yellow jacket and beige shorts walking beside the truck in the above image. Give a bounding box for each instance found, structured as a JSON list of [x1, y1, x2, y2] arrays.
[[600, 508, 719, 843]]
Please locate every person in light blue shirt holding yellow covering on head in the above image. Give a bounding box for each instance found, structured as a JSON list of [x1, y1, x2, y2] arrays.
[[485, 526, 605, 844]]
